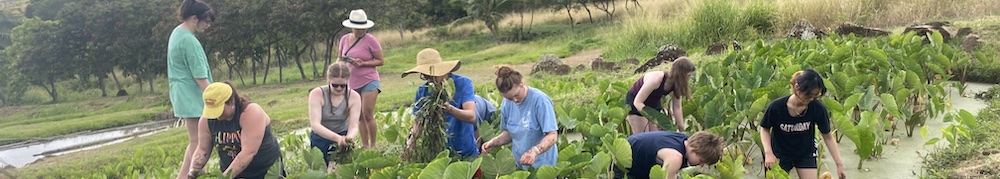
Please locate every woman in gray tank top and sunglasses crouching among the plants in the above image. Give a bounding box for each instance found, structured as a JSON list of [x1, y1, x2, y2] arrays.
[[309, 62, 361, 173]]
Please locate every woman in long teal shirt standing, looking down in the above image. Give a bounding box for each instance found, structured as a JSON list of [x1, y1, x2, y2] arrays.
[[167, 0, 215, 178]]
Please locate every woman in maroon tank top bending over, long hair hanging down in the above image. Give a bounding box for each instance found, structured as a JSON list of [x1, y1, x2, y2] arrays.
[[625, 57, 695, 134]]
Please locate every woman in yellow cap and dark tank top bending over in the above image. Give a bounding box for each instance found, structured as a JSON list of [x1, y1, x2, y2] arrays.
[[187, 83, 285, 178]]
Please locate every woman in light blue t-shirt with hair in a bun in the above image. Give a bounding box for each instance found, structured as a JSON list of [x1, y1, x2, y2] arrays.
[[483, 66, 559, 169]]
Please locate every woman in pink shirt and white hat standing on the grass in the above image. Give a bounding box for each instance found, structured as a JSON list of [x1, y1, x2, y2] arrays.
[[337, 9, 385, 148]]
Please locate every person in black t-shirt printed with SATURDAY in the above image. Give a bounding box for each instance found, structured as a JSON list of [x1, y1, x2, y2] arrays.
[[760, 69, 846, 179]]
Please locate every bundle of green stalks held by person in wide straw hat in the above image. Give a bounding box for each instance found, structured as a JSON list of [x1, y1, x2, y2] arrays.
[[402, 83, 451, 163]]
